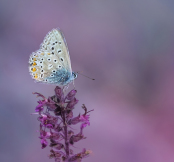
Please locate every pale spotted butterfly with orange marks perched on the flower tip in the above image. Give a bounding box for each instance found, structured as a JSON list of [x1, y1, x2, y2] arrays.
[[29, 29, 77, 86]]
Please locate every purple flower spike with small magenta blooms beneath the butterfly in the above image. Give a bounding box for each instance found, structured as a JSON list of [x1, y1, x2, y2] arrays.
[[33, 86, 93, 162]]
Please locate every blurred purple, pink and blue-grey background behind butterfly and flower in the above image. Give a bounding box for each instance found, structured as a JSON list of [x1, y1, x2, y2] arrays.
[[0, 0, 174, 162]]
